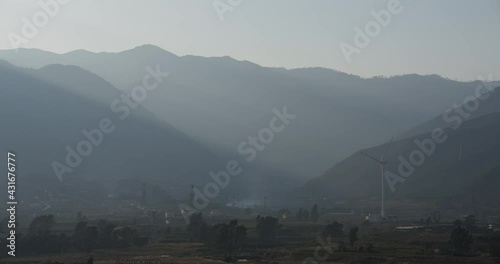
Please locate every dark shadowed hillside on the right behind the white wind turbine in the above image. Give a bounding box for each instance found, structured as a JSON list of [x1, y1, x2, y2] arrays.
[[298, 97, 500, 206]]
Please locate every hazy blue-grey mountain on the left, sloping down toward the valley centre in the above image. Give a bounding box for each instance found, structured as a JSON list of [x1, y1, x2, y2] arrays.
[[0, 61, 222, 197]]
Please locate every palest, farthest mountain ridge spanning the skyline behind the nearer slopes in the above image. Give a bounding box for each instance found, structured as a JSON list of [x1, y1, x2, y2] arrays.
[[0, 45, 496, 181]]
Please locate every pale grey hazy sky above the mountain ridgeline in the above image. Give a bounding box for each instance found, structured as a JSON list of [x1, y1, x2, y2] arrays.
[[0, 0, 500, 80]]
